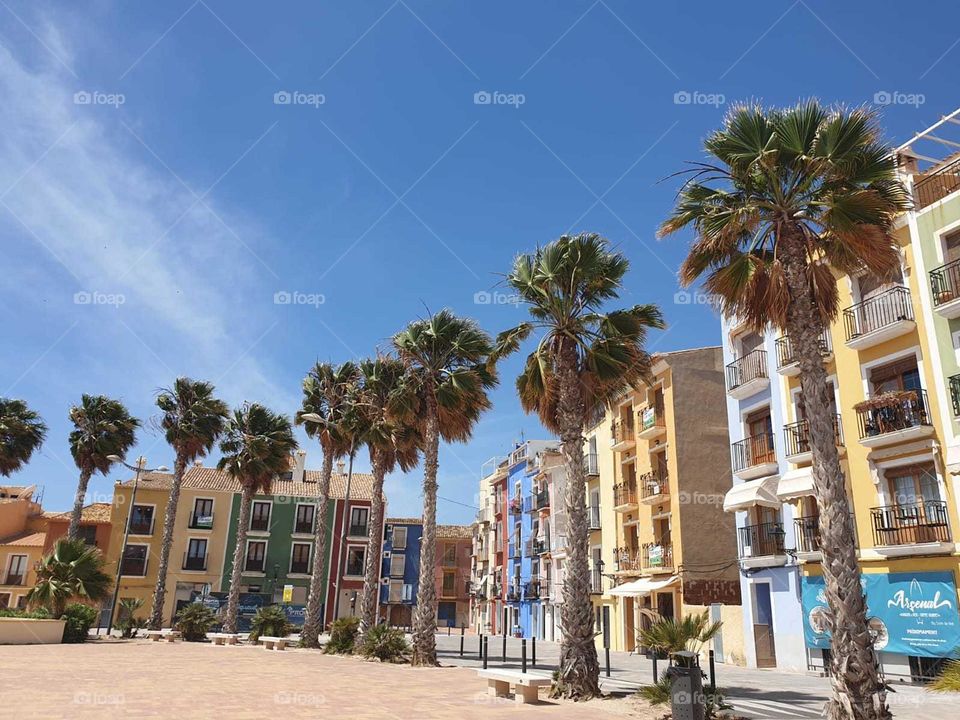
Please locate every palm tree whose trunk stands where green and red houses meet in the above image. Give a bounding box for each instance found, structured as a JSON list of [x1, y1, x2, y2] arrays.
[[296, 362, 360, 648]]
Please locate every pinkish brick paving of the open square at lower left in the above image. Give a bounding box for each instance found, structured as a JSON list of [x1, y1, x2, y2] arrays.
[[0, 640, 623, 720]]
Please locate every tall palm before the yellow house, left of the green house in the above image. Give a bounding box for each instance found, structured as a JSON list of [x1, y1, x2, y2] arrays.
[[149, 377, 230, 630]]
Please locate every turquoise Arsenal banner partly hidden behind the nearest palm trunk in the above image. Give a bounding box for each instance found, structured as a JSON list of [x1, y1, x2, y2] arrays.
[[801, 572, 960, 658]]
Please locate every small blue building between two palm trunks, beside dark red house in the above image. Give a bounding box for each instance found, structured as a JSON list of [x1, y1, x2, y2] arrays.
[[380, 518, 423, 627]]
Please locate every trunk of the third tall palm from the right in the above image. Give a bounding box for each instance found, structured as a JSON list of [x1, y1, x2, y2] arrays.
[[411, 391, 440, 666]]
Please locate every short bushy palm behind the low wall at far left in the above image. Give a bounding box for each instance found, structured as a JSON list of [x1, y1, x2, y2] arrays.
[[27, 538, 113, 618]]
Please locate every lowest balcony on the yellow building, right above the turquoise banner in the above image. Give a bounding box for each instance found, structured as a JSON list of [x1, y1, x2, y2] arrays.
[[870, 500, 953, 557]]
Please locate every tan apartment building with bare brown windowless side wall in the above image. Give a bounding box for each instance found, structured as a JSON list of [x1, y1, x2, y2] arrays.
[[599, 347, 744, 664]]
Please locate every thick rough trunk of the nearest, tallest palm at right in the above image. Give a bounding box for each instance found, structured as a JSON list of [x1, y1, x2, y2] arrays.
[[779, 223, 892, 720]]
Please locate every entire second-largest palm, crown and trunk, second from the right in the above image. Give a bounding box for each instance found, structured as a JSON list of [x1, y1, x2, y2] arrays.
[[496, 233, 664, 699]]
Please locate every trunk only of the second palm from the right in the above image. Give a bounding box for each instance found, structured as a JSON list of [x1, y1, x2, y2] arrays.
[[557, 343, 600, 700]]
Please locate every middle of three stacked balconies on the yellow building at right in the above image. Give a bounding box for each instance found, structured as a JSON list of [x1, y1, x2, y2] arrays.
[[853, 390, 934, 448]]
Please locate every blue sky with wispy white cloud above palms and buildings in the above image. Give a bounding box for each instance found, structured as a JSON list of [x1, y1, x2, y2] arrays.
[[0, 0, 960, 522]]
